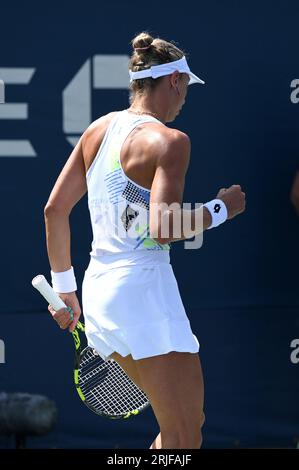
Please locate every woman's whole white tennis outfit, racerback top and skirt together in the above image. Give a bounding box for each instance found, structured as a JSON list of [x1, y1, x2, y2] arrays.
[[82, 110, 199, 360]]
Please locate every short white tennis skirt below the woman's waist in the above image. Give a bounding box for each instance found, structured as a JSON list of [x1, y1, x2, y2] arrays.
[[82, 253, 199, 360]]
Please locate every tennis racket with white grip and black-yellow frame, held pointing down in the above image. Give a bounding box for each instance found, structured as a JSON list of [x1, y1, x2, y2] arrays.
[[32, 274, 149, 419]]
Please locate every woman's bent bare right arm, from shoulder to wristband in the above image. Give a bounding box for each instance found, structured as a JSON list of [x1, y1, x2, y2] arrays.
[[150, 131, 212, 244]]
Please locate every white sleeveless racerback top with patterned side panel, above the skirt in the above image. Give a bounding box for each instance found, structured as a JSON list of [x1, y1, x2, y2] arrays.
[[86, 110, 170, 266]]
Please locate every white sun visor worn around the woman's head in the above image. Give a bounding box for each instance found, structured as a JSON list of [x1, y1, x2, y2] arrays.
[[129, 56, 205, 85]]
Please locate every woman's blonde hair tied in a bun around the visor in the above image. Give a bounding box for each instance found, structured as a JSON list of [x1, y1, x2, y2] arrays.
[[129, 31, 187, 104]]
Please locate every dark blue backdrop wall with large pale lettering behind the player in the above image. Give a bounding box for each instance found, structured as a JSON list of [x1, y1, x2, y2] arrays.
[[0, 0, 299, 448]]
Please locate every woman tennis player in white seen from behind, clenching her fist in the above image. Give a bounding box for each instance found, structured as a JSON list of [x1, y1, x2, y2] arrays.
[[45, 32, 245, 449]]
